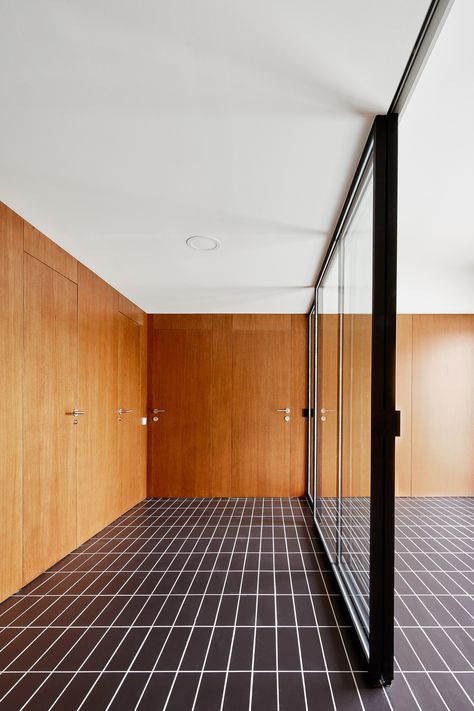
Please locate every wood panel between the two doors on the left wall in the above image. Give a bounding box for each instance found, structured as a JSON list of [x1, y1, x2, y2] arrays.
[[77, 264, 122, 543]]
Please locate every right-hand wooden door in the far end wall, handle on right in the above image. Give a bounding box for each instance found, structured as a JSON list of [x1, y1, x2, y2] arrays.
[[232, 321, 290, 496]]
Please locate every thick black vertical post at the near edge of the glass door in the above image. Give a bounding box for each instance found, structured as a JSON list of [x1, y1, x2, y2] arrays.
[[369, 114, 398, 684]]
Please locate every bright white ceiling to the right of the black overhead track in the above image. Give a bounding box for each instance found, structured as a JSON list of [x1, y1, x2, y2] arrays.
[[398, 0, 474, 313]]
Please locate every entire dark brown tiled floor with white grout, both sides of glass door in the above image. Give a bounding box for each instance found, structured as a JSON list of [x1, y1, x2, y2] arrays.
[[0, 499, 474, 711]]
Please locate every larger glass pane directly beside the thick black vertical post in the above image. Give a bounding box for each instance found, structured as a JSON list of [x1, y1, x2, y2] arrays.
[[339, 169, 373, 631]]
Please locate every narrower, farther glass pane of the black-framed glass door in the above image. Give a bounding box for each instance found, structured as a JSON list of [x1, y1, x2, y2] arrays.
[[315, 248, 340, 563]]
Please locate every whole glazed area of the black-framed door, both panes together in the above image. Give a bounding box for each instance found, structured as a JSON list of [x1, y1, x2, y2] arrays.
[[314, 164, 373, 636]]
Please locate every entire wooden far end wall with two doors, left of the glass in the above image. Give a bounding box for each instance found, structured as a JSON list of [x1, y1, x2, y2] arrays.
[[148, 314, 307, 496]]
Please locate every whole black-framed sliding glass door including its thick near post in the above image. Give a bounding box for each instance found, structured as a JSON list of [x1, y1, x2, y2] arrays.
[[308, 115, 397, 684]]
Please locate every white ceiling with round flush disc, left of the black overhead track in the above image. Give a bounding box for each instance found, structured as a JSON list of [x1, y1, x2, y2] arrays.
[[0, 0, 430, 312]]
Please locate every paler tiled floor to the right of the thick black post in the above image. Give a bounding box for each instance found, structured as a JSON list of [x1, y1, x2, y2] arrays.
[[393, 497, 474, 711]]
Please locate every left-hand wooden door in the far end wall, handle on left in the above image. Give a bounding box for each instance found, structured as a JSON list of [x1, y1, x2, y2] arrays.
[[149, 327, 212, 497]]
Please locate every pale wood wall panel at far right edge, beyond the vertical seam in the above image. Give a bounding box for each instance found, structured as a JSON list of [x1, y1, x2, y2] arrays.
[[412, 314, 474, 496]]
